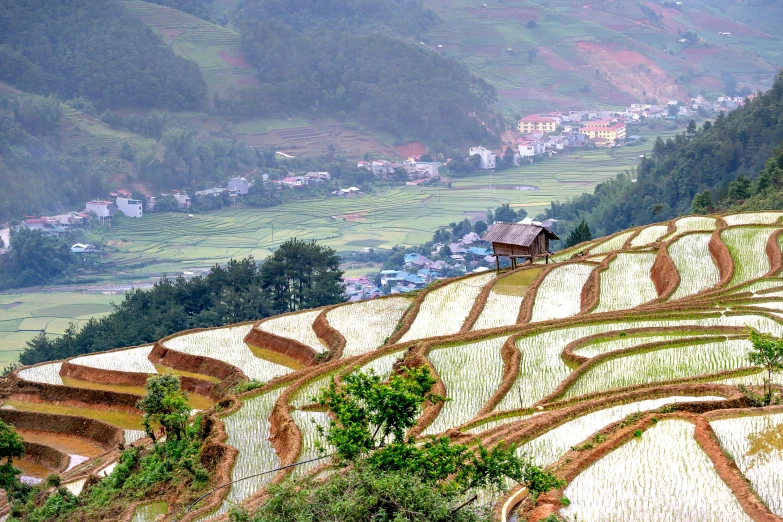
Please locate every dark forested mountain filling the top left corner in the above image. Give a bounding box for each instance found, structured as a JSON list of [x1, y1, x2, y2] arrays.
[[0, 0, 206, 109]]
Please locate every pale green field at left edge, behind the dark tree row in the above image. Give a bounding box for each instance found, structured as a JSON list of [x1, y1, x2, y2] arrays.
[[0, 292, 122, 367]]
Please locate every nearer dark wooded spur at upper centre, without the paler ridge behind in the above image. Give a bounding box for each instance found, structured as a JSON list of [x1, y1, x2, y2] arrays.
[[222, 24, 499, 143]]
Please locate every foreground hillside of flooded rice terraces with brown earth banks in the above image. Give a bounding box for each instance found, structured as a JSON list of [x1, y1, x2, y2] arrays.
[[0, 212, 783, 522]]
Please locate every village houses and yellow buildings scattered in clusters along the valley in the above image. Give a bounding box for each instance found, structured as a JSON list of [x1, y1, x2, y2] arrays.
[[0, 95, 752, 294]]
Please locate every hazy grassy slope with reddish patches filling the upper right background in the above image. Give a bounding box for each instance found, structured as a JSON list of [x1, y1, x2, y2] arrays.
[[426, 0, 783, 112]]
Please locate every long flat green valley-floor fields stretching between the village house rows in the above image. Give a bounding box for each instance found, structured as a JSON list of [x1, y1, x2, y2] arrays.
[[99, 134, 668, 276]]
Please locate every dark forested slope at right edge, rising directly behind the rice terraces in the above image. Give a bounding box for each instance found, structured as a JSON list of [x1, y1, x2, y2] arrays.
[[544, 73, 783, 236]]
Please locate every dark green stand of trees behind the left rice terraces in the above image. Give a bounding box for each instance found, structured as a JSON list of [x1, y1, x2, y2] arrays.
[[19, 239, 345, 364]]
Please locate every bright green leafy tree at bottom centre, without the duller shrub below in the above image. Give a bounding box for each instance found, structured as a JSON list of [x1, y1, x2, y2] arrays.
[[319, 367, 563, 502]]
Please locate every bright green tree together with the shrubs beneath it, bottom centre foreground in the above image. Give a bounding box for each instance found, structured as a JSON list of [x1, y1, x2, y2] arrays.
[[231, 367, 565, 522]]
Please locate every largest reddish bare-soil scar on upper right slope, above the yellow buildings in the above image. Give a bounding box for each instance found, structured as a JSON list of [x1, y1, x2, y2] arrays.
[[576, 41, 687, 101]]
